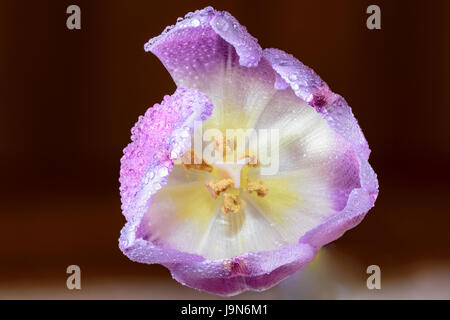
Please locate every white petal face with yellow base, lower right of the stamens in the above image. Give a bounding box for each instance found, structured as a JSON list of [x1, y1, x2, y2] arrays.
[[244, 169, 353, 246]]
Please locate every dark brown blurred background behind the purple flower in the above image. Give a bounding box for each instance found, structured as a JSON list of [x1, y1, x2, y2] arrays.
[[0, 0, 450, 299]]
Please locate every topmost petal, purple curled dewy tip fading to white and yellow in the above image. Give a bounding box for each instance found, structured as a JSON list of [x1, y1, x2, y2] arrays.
[[146, 8, 276, 128]]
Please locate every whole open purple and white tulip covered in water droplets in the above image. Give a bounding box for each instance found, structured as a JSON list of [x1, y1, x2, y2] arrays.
[[119, 7, 378, 295]]
